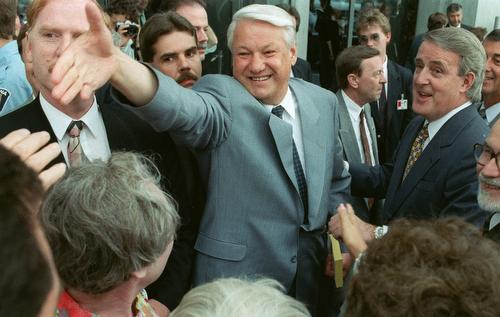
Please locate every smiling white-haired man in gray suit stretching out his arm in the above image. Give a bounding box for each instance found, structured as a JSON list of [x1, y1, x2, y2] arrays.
[[47, 0, 350, 315]]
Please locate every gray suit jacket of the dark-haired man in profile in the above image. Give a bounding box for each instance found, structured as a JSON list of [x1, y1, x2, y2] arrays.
[[336, 90, 382, 222]]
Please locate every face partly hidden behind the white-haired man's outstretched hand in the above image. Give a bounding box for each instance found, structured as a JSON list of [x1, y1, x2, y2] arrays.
[[26, 0, 89, 103]]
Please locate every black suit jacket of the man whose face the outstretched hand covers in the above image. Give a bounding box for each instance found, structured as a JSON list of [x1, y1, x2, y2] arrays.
[[0, 87, 204, 309]]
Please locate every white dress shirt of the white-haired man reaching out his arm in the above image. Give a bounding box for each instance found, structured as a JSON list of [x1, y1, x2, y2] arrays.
[[264, 87, 306, 175]]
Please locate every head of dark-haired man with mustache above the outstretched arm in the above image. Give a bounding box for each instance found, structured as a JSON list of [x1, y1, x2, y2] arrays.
[[139, 11, 201, 88]]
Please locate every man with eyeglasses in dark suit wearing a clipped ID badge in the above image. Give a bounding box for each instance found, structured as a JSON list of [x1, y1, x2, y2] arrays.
[[357, 9, 414, 163]]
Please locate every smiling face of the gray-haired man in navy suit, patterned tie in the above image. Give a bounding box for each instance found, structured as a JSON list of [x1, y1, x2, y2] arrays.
[[413, 41, 474, 121]]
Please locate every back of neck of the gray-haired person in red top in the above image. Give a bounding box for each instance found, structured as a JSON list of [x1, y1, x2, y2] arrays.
[[67, 279, 141, 317]]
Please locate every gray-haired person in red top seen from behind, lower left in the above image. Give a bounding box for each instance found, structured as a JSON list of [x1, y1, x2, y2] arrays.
[[40, 152, 179, 316]]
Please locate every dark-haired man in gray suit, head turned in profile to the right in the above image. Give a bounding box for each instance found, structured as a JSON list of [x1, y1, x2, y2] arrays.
[[336, 46, 386, 223]]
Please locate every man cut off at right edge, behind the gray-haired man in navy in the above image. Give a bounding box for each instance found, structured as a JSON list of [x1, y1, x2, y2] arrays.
[[479, 30, 500, 127]]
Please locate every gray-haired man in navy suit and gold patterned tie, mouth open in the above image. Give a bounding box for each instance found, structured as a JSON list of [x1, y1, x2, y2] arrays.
[[330, 28, 488, 241]]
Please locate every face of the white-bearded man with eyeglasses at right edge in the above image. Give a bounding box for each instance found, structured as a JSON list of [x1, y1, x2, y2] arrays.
[[476, 121, 500, 212]]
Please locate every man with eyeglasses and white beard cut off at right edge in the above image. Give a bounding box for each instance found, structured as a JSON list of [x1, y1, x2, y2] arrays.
[[474, 122, 500, 243]]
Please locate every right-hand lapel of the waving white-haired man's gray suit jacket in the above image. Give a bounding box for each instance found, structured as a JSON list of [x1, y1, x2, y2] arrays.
[[290, 80, 324, 218]]
